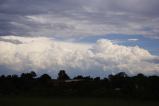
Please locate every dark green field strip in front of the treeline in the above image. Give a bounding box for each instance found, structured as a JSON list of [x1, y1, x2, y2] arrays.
[[0, 97, 159, 106]]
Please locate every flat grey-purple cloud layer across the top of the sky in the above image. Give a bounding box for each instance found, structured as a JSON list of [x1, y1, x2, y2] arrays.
[[0, 0, 159, 38]]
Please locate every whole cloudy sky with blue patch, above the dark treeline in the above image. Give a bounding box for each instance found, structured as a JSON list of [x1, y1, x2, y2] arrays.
[[0, 0, 159, 77]]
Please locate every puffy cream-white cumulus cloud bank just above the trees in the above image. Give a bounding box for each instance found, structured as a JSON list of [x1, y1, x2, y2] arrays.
[[0, 36, 159, 76]]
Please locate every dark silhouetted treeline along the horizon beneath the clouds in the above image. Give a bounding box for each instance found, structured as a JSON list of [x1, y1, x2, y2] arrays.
[[0, 70, 159, 99]]
